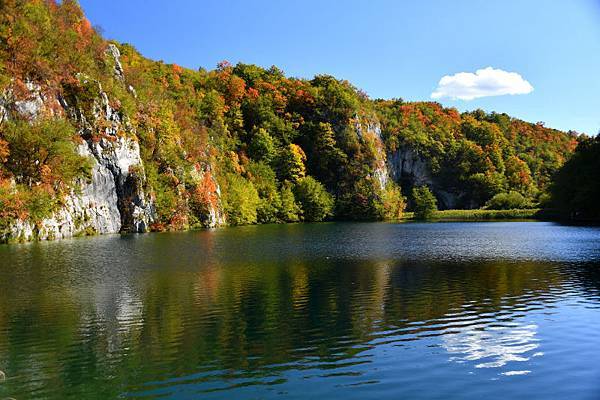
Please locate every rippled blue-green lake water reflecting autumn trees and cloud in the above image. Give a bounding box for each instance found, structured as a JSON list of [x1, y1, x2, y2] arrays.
[[0, 222, 600, 400]]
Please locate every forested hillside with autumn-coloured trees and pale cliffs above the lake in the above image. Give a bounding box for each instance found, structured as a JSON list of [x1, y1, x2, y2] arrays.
[[0, 0, 579, 239]]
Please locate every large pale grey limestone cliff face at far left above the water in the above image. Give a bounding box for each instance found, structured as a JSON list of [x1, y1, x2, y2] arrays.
[[0, 47, 155, 241]]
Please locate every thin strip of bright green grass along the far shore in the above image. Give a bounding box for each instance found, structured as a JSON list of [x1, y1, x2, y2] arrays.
[[402, 208, 551, 221]]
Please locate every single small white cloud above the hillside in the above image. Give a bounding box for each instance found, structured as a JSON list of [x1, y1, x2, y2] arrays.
[[431, 67, 533, 100]]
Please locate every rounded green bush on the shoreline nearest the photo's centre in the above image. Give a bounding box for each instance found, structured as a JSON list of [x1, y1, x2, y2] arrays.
[[294, 176, 333, 222]]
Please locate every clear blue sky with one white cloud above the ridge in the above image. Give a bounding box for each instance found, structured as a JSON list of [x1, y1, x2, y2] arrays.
[[80, 0, 600, 134]]
